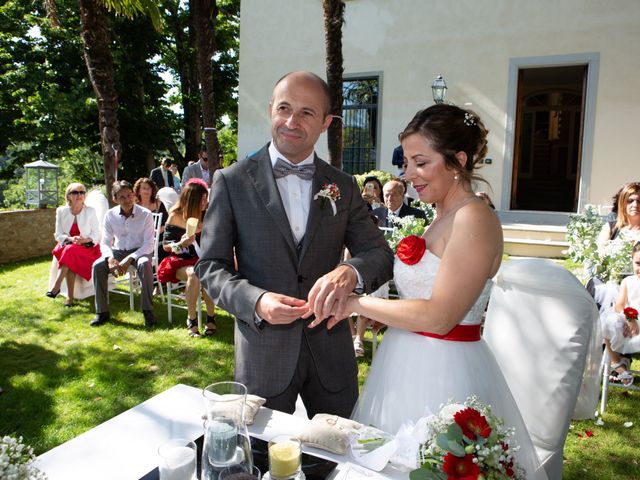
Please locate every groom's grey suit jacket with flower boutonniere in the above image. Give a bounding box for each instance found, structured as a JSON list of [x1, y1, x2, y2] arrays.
[[196, 145, 393, 397]]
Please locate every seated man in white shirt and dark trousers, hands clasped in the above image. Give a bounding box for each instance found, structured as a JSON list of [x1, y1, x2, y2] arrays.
[[91, 180, 156, 327]]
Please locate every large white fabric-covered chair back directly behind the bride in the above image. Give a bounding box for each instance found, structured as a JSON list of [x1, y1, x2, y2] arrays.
[[483, 259, 602, 479]]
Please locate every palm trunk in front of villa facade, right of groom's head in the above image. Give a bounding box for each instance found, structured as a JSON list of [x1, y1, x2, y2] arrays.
[[322, 0, 344, 168]]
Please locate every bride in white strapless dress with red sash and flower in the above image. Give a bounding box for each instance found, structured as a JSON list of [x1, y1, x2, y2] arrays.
[[316, 104, 546, 479]]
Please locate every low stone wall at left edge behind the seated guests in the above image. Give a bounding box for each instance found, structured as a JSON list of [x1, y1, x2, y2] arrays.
[[0, 208, 56, 264]]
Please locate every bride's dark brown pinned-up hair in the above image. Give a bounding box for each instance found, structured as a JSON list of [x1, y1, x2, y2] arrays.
[[398, 103, 489, 186]]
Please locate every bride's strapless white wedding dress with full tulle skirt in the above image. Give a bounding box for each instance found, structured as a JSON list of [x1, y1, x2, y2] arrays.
[[353, 250, 547, 480]]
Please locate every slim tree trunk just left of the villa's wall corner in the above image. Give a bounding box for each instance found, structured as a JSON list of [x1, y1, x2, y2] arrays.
[[191, 0, 220, 175]]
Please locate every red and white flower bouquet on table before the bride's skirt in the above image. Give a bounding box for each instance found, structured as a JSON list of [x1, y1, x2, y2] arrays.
[[409, 396, 525, 480]]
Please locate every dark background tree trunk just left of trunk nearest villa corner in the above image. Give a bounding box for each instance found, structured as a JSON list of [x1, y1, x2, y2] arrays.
[[167, 2, 202, 166]]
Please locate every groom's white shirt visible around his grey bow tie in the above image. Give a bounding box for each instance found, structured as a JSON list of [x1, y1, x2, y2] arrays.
[[269, 140, 315, 243]]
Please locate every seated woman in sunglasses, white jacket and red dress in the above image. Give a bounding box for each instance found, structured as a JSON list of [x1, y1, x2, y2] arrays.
[[47, 183, 100, 307]]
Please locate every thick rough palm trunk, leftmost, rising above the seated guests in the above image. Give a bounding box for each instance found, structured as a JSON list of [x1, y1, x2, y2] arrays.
[[79, 0, 122, 201]]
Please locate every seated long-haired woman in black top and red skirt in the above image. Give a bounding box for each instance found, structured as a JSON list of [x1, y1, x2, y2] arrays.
[[158, 178, 216, 337]]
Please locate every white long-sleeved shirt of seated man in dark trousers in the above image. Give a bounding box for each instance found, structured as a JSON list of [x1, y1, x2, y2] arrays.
[[100, 204, 153, 260]]
